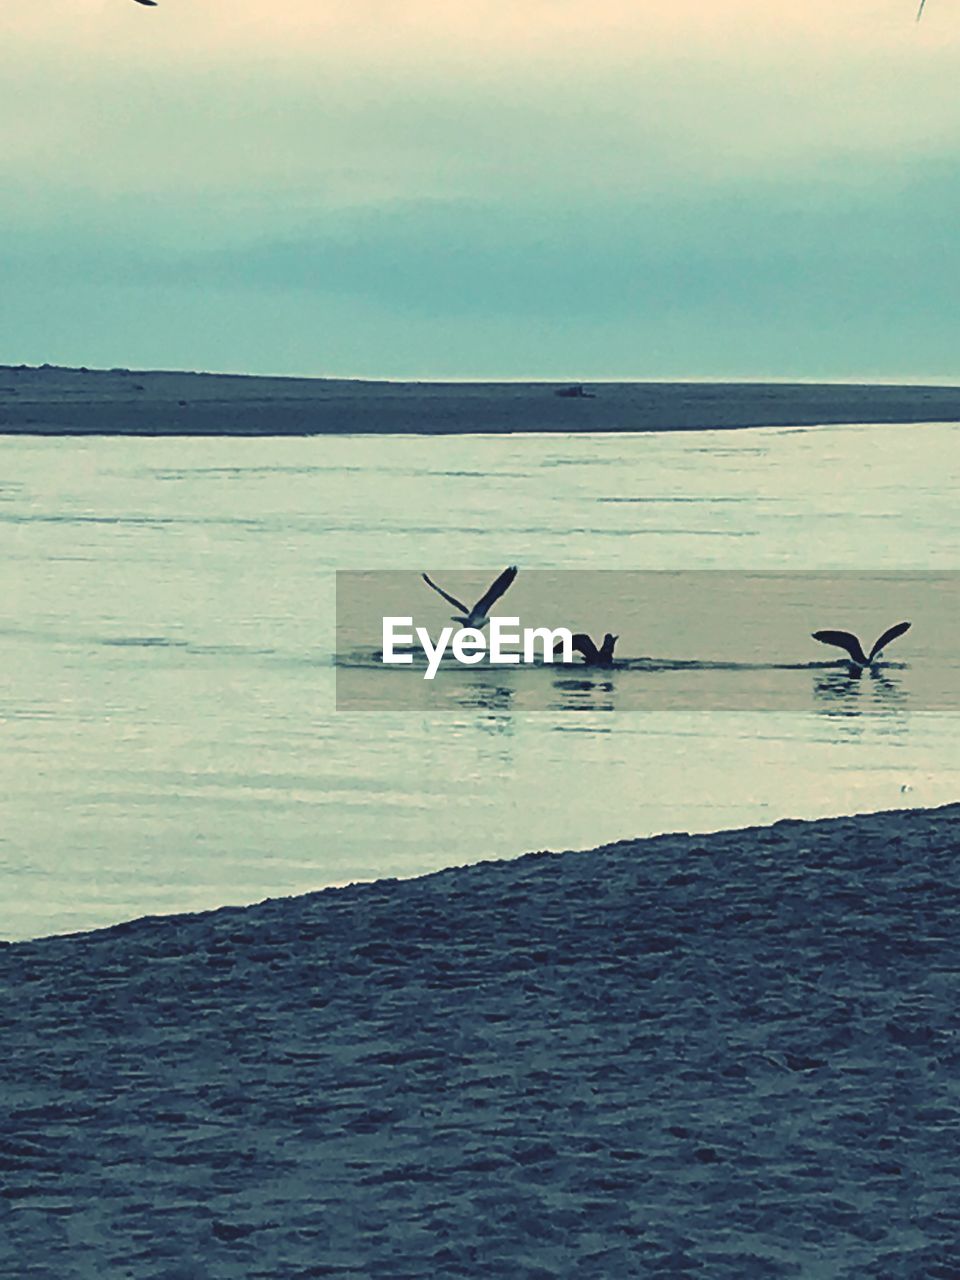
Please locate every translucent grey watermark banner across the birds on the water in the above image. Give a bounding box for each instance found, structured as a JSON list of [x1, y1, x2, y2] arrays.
[[334, 567, 960, 716]]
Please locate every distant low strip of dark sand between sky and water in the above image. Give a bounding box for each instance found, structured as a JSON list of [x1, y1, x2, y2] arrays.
[[0, 366, 960, 435]]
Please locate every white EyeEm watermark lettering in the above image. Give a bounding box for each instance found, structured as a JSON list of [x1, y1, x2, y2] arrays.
[[383, 617, 573, 680]]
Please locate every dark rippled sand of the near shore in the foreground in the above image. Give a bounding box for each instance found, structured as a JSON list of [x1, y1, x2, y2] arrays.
[[0, 805, 960, 1280]]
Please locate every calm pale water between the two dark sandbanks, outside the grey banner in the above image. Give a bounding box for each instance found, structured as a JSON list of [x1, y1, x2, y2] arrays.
[[0, 426, 960, 938]]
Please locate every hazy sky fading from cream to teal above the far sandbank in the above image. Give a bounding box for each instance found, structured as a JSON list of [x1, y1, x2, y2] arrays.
[[0, 0, 960, 381]]
